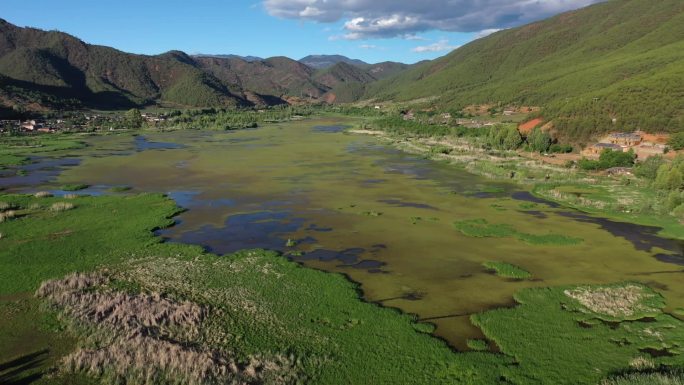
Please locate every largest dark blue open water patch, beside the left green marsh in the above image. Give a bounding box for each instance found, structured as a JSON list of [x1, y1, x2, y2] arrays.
[[159, 211, 305, 254]]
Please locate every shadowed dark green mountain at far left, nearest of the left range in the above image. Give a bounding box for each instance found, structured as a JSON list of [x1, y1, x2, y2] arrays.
[[0, 20, 247, 108]]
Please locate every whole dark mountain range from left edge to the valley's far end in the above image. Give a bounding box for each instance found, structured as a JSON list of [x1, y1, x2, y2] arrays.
[[0, 19, 412, 115]]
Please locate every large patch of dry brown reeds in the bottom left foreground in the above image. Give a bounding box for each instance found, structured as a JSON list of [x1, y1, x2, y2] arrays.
[[36, 274, 296, 385]]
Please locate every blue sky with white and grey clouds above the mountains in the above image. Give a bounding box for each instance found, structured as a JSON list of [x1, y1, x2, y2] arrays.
[[0, 0, 601, 63]]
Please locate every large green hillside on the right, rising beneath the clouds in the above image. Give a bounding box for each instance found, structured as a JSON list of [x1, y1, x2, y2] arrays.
[[365, 0, 684, 139]]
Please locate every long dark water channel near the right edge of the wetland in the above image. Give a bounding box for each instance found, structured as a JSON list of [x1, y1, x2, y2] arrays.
[[558, 211, 684, 258]]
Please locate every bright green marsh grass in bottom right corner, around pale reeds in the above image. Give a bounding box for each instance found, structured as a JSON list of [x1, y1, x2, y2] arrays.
[[471, 283, 684, 385]]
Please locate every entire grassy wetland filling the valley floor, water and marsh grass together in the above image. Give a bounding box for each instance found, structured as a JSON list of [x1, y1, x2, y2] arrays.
[[0, 117, 684, 385]]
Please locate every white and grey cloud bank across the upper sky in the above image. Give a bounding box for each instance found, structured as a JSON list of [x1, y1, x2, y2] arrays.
[[263, 0, 604, 40]]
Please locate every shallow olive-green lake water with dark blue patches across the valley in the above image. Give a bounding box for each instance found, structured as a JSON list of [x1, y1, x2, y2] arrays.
[[29, 119, 684, 349]]
